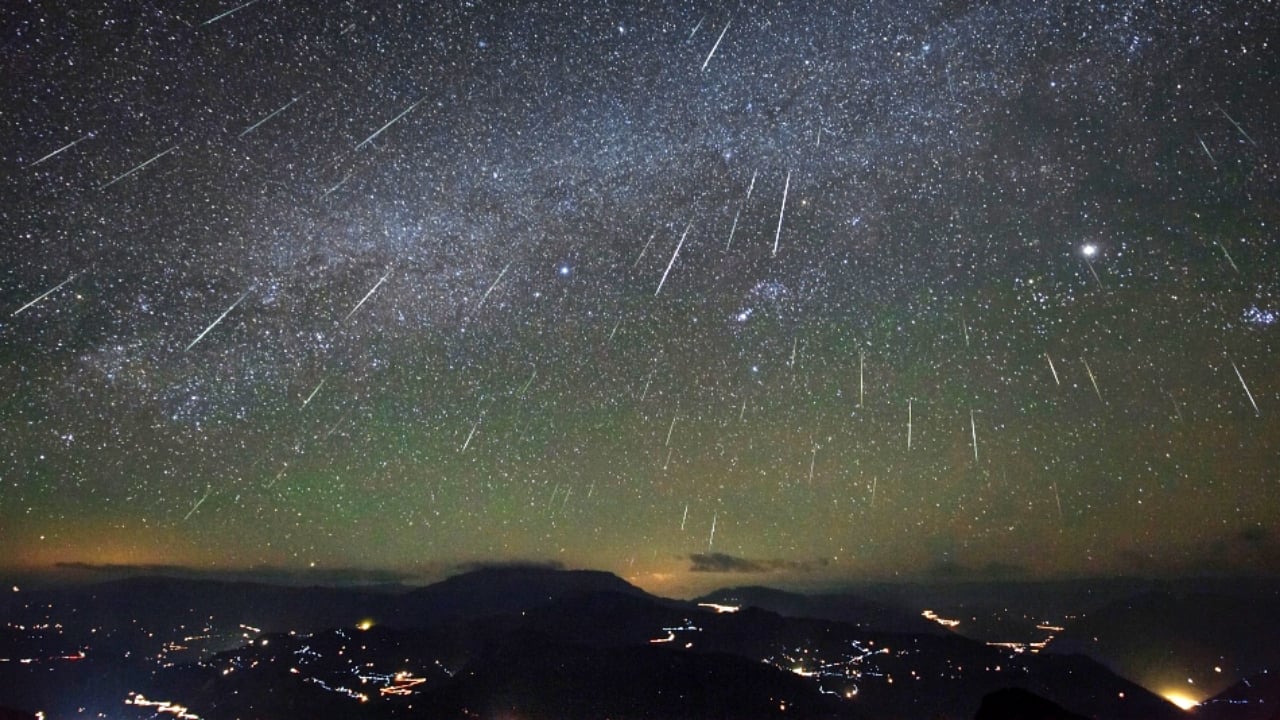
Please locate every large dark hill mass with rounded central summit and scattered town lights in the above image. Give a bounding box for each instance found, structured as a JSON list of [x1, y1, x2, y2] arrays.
[[0, 568, 1185, 720]]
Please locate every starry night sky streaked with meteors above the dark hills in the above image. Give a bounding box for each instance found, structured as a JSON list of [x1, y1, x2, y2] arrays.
[[0, 0, 1280, 592]]
